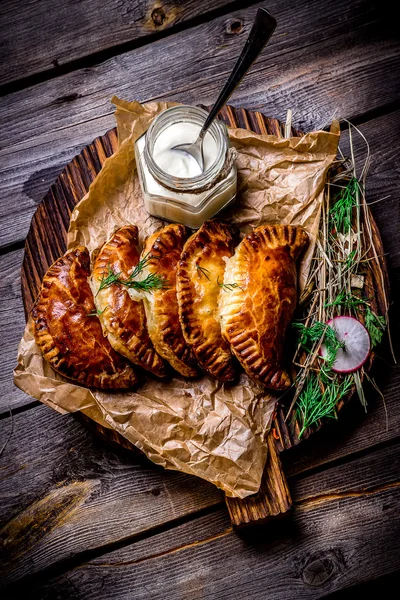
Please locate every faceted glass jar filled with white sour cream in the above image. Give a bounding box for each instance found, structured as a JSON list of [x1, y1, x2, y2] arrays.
[[135, 106, 237, 228]]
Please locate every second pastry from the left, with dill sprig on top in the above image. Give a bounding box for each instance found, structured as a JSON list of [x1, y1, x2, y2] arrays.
[[91, 225, 166, 377]]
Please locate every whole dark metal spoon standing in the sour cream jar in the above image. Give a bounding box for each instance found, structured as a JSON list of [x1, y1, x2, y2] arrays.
[[171, 8, 276, 172]]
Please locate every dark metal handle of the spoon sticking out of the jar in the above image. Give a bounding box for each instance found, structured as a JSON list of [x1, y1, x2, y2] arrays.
[[199, 8, 276, 138]]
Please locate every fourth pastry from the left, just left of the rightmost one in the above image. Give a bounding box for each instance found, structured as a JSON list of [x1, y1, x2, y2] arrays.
[[177, 221, 235, 381]]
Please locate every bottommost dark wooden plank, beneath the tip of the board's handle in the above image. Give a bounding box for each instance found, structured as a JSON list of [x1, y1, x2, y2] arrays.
[[6, 445, 400, 600]]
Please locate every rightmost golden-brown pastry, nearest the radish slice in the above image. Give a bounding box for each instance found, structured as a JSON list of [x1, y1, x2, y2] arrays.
[[219, 225, 308, 390]]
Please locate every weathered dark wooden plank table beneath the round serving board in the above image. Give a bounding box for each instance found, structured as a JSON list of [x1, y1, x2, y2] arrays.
[[0, 0, 400, 600]]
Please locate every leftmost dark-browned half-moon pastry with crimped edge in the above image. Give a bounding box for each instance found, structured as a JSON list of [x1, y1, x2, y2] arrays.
[[32, 246, 137, 389]]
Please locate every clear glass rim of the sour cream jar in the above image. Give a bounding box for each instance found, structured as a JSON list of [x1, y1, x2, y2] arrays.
[[143, 104, 229, 192]]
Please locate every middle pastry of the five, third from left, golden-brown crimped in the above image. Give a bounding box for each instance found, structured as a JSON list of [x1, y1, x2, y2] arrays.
[[142, 224, 199, 377]]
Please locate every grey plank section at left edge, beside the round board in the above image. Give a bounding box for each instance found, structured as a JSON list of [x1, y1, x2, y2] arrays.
[[0, 250, 33, 414]]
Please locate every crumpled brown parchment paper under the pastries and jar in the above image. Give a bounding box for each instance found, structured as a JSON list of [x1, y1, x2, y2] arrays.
[[14, 98, 339, 498]]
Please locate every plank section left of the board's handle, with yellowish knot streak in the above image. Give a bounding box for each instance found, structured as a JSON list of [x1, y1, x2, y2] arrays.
[[0, 406, 223, 578]]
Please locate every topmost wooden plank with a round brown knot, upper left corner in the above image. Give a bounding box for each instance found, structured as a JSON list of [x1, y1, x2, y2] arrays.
[[0, 0, 238, 85]]
